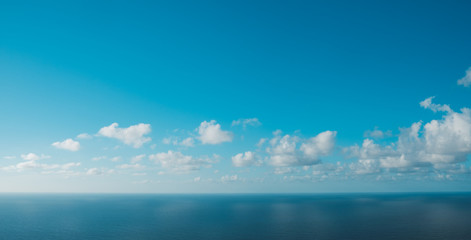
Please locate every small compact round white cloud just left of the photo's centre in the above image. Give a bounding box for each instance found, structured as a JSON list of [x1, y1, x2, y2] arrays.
[[197, 120, 233, 144]]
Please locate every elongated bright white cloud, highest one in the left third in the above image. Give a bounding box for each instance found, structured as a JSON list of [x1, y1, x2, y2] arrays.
[[98, 123, 151, 148]]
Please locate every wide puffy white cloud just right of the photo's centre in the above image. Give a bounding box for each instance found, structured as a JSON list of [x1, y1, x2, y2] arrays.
[[266, 131, 337, 167]]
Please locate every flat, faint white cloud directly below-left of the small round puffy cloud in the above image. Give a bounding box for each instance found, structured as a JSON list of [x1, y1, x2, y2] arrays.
[[149, 150, 218, 173]]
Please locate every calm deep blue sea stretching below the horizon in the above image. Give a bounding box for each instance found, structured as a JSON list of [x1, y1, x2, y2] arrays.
[[0, 193, 471, 240]]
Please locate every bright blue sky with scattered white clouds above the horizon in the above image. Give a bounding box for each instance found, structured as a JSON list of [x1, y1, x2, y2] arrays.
[[0, 1, 471, 193]]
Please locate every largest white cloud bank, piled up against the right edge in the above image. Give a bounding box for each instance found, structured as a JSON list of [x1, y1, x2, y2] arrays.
[[348, 98, 471, 173]]
